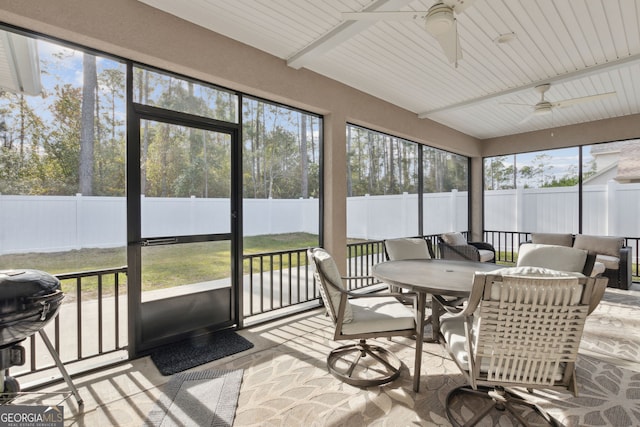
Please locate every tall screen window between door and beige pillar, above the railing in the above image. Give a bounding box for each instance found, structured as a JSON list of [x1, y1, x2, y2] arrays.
[[242, 97, 322, 253]]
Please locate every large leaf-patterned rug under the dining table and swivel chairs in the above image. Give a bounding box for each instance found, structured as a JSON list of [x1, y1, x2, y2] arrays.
[[223, 290, 640, 427]]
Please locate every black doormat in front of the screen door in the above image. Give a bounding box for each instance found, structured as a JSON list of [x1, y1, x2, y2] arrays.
[[150, 329, 253, 375]]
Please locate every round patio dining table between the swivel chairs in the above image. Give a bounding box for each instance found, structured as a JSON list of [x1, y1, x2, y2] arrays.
[[372, 259, 502, 392]]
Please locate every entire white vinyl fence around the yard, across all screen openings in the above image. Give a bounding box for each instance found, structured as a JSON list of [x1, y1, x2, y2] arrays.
[[0, 181, 640, 254]]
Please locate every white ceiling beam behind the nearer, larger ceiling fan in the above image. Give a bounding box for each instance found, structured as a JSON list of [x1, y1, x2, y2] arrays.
[[287, 0, 414, 70]]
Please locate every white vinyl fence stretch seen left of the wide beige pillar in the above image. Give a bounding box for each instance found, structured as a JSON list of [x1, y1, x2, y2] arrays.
[[0, 195, 319, 254]]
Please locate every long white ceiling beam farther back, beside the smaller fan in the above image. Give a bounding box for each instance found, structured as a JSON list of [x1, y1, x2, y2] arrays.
[[418, 54, 640, 119]]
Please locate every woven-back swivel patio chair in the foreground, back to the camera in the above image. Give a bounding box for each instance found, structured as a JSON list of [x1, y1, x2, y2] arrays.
[[440, 267, 607, 426]]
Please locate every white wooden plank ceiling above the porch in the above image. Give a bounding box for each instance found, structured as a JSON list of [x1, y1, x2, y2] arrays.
[[140, 0, 640, 139]]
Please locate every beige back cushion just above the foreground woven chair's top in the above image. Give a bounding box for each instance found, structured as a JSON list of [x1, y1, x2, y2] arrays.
[[517, 243, 587, 272]]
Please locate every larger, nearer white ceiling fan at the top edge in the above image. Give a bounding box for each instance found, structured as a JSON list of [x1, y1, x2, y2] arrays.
[[342, 0, 475, 66]]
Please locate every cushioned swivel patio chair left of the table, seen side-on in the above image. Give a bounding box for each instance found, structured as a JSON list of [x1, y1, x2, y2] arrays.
[[307, 248, 416, 387]]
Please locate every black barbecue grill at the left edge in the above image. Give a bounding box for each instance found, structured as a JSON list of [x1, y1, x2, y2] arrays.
[[0, 270, 64, 398]]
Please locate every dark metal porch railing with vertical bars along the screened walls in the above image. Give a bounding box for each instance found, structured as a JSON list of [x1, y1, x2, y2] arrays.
[[11, 231, 640, 377]]
